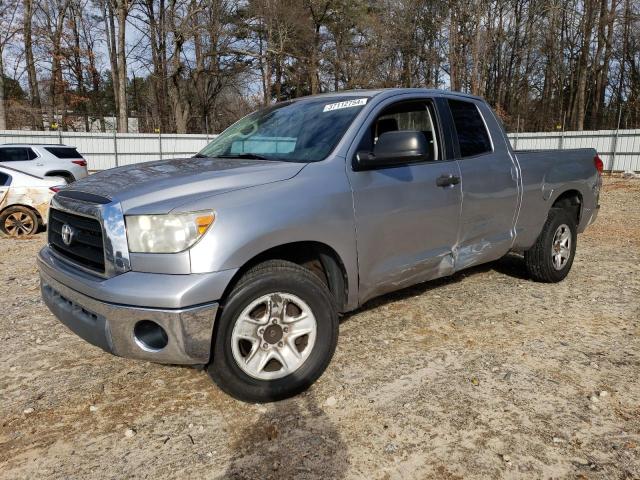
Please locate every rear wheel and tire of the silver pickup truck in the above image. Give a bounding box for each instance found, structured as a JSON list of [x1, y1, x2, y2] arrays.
[[524, 208, 578, 283]]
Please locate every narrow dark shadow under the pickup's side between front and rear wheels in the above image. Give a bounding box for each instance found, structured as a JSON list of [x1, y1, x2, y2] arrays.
[[340, 253, 531, 322]]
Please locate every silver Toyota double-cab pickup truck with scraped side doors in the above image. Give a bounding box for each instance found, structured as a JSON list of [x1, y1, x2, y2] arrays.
[[38, 89, 602, 402]]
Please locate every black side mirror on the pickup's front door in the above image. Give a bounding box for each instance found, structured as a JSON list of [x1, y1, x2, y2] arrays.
[[355, 130, 429, 170]]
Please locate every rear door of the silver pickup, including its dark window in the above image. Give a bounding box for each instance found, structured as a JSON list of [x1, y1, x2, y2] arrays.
[[447, 98, 519, 270]]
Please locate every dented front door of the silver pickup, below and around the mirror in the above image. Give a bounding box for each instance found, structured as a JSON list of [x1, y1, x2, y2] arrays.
[[347, 98, 461, 302]]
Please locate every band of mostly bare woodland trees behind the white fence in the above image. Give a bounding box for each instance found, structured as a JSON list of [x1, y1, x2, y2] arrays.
[[0, 0, 640, 132]]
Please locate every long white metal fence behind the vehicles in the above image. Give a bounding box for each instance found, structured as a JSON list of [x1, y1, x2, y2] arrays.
[[0, 130, 640, 171]]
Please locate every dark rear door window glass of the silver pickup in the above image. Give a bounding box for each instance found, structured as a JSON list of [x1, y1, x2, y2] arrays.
[[449, 100, 491, 157]]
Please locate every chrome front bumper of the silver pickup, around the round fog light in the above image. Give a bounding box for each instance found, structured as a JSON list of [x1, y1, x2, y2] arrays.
[[40, 268, 218, 365]]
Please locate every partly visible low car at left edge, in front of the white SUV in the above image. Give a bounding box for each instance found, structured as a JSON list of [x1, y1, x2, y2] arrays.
[[0, 167, 65, 237]]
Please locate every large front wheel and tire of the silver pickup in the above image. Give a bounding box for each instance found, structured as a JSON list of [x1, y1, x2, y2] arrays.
[[207, 260, 338, 403]]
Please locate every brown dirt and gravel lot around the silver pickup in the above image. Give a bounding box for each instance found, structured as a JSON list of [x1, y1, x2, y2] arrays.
[[0, 179, 640, 479]]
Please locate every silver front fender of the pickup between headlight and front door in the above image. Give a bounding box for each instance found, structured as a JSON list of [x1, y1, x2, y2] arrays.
[[182, 158, 358, 305]]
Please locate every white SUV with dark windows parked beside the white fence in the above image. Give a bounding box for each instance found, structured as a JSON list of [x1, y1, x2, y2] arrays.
[[0, 144, 87, 183]]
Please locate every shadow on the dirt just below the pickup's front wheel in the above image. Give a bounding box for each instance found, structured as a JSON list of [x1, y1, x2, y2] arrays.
[[218, 391, 349, 480]]
